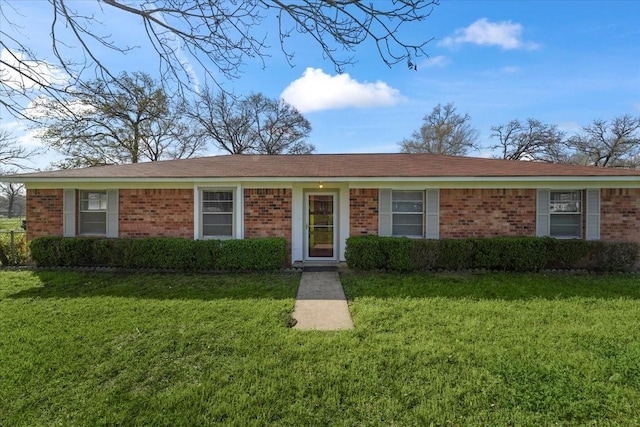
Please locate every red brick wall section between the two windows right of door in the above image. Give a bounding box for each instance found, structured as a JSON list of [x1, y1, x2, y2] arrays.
[[440, 189, 536, 238]]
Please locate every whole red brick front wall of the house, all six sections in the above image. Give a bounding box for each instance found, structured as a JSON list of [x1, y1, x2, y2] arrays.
[[26, 188, 640, 261]]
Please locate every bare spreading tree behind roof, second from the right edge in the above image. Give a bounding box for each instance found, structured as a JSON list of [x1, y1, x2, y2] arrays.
[[490, 118, 566, 163]]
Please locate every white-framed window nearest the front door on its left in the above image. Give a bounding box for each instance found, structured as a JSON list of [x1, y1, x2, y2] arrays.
[[202, 190, 233, 238]]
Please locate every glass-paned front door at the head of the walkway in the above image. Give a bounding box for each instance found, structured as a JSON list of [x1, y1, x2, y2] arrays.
[[305, 193, 337, 260]]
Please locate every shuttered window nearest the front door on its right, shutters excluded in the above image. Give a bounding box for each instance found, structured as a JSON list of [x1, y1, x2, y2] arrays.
[[391, 191, 424, 237]]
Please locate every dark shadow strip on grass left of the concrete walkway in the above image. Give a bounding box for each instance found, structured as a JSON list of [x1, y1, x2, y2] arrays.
[[7, 271, 300, 300]]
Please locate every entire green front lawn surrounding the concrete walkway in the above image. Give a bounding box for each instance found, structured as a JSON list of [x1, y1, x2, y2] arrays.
[[0, 271, 640, 426]]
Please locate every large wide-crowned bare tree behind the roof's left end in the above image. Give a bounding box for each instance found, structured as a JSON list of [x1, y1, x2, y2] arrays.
[[36, 72, 205, 167]]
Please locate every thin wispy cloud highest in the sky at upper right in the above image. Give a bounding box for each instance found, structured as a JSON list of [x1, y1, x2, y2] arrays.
[[438, 18, 539, 50]]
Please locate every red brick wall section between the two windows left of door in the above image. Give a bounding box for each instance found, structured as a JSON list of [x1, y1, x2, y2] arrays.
[[118, 189, 194, 239]]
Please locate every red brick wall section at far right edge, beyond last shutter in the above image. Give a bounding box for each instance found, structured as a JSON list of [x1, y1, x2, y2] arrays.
[[600, 188, 640, 242]]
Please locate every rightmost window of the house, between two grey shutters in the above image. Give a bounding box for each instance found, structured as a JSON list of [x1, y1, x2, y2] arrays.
[[549, 191, 582, 238]]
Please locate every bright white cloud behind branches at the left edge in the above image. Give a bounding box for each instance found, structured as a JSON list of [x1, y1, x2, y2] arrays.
[[0, 49, 66, 90]]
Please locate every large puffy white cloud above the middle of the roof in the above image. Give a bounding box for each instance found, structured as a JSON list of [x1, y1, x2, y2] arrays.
[[280, 68, 402, 113]]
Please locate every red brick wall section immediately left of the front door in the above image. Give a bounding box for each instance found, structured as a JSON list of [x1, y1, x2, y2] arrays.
[[244, 188, 292, 264]]
